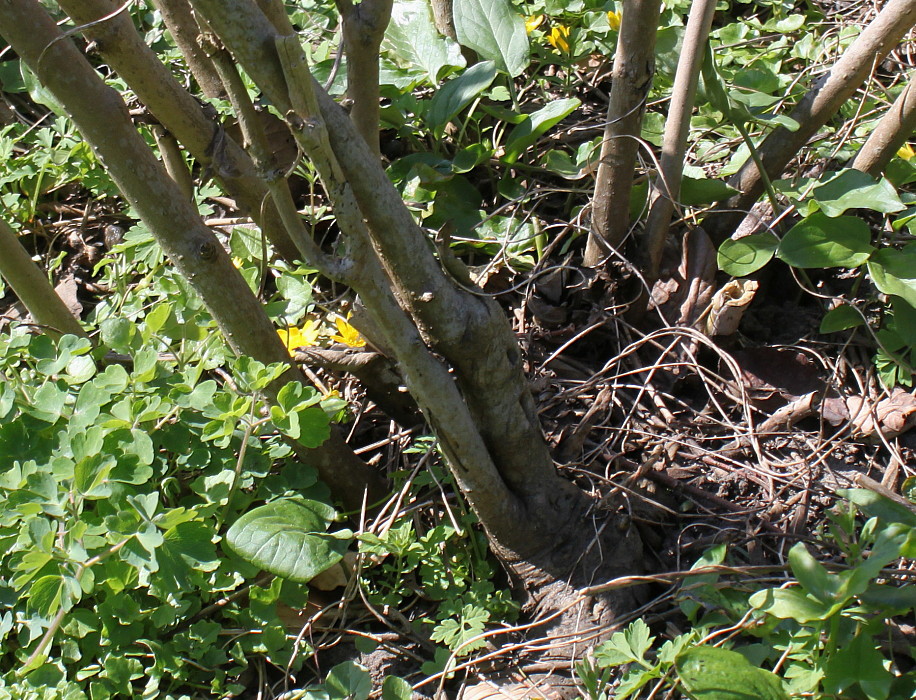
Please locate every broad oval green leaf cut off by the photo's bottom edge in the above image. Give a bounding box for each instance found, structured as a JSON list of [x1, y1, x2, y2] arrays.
[[675, 647, 788, 700]]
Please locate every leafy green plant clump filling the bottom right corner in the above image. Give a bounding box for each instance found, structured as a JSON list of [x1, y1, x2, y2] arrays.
[[577, 489, 916, 700]]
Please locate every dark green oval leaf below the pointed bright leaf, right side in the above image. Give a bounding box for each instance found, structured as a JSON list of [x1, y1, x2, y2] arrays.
[[776, 212, 874, 268]]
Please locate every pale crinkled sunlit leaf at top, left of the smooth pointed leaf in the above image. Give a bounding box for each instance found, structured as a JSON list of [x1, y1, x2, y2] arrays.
[[382, 0, 465, 85]]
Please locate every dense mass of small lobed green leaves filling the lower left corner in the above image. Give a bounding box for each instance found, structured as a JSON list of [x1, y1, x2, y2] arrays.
[[0, 326, 347, 698]]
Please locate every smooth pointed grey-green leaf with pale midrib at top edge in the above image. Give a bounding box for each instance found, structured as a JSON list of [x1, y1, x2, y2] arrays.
[[452, 0, 529, 78]]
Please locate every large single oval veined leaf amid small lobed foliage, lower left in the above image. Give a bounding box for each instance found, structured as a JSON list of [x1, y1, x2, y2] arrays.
[[226, 499, 349, 583]]
